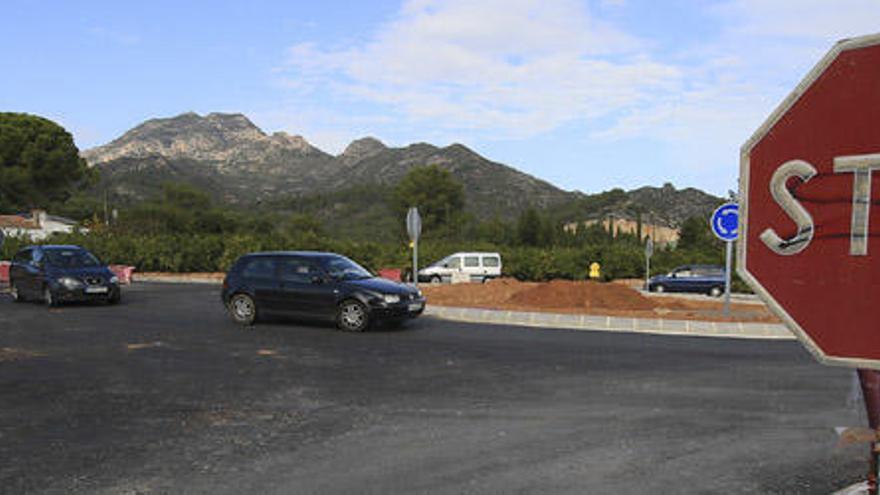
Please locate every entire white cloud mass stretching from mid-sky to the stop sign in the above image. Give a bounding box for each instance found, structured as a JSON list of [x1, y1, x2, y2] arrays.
[[278, 0, 880, 193]]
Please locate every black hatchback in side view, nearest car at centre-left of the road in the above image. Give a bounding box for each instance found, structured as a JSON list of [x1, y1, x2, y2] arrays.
[[221, 251, 425, 332]]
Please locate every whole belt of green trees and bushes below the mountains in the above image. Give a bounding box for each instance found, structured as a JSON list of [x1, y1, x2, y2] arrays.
[[0, 114, 744, 288]]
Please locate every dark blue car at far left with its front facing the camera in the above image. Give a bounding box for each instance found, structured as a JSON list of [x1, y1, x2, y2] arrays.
[[9, 246, 121, 306]]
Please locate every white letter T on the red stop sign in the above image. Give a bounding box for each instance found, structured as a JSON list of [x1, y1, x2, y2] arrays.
[[834, 153, 880, 256]]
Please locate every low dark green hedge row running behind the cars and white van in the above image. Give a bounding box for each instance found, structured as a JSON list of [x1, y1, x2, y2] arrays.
[[2, 232, 744, 290]]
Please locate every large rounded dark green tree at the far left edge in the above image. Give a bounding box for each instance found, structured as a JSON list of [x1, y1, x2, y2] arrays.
[[0, 112, 95, 210]]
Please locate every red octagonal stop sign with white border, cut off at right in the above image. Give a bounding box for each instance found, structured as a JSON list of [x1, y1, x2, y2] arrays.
[[738, 35, 880, 368]]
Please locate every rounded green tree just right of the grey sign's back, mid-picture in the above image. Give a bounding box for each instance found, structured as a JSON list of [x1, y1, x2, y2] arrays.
[[392, 165, 464, 237]]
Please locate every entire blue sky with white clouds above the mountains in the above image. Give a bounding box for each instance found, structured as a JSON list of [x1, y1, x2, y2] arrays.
[[0, 0, 880, 198]]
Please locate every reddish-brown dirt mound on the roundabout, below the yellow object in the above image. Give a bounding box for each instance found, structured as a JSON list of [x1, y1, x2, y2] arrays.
[[509, 280, 655, 311]]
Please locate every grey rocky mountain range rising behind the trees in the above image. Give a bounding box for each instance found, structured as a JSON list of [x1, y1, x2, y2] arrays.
[[83, 113, 720, 225]]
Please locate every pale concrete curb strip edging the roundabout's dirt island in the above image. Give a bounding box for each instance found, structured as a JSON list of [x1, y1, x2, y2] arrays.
[[424, 305, 795, 340]]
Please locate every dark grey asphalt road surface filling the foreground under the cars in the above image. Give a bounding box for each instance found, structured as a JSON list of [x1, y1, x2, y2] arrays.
[[0, 284, 866, 494]]
